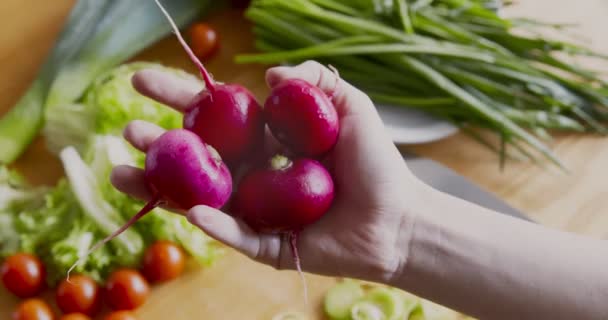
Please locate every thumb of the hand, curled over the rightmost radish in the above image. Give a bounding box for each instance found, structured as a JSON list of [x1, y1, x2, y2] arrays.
[[266, 61, 376, 117]]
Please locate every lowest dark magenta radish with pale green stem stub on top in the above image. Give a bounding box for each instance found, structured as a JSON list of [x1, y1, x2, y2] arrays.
[[235, 155, 334, 233]]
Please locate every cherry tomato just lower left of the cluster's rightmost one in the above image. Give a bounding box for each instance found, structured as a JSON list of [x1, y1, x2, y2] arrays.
[[106, 269, 150, 310]]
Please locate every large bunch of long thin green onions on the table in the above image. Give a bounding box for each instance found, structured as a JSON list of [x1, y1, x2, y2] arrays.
[[237, 0, 608, 165]]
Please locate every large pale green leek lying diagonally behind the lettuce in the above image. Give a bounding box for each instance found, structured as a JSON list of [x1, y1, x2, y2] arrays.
[[0, 0, 211, 164]]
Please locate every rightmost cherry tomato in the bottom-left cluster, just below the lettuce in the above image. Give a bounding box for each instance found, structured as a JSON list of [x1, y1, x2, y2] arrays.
[[143, 241, 186, 282]]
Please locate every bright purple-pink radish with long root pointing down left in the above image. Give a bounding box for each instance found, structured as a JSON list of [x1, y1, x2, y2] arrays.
[[68, 129, 232, 281]]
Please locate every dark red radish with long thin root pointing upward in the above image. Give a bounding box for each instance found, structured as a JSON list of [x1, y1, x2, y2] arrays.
[[156, 0, 265, 164]]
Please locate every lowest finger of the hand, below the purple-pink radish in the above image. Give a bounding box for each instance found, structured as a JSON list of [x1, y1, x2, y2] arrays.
[[187, 206, 284, 269]]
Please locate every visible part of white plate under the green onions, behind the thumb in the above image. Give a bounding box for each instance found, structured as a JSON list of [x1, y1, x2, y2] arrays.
[[376, 105, 458, 144]]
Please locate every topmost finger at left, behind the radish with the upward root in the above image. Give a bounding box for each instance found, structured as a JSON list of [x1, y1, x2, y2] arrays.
[[131, 69, 203, 112]]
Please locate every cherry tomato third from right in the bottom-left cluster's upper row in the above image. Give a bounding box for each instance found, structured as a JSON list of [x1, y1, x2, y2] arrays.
[[55, 275, 101, 316]]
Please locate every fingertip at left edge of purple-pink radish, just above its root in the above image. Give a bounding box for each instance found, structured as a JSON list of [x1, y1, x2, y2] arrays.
[[110, 166, 152, 201]]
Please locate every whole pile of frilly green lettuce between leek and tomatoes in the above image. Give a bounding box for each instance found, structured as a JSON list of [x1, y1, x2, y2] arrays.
[[0, 63, 221, 286]]
